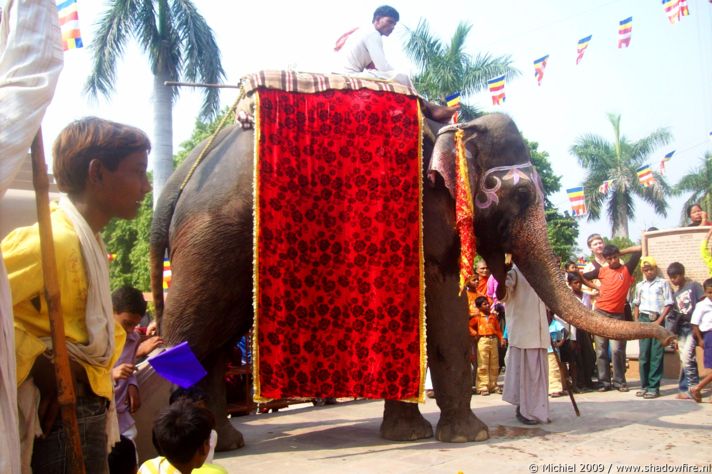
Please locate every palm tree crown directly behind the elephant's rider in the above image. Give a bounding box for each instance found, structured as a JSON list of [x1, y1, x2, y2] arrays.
[[405, 20, 520, 120]]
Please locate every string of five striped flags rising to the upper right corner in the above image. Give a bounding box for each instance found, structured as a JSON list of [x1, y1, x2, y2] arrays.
[[487, 0, 690, 105]]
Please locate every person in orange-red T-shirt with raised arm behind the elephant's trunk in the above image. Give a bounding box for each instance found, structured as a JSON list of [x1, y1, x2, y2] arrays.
[[583, 245, 641, 392]]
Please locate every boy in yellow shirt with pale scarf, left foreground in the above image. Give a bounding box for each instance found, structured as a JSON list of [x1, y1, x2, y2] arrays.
[[2, 117, 151, 473]]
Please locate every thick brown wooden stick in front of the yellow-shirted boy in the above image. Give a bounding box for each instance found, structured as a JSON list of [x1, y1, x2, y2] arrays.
[[32, 129, 85, 474]]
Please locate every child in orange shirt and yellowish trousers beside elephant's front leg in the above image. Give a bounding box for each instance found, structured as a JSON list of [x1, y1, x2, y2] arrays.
[[469, 296, 503, 395]]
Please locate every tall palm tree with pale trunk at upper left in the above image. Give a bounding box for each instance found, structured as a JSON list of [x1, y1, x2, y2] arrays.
[[86, 0, 225, 204]]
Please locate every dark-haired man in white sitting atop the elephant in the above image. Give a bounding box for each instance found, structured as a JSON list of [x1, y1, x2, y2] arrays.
[[334, 5, 457, 122]]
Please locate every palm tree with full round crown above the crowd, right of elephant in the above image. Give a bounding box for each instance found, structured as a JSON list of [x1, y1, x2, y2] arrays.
[[570, 114, 671, 238]]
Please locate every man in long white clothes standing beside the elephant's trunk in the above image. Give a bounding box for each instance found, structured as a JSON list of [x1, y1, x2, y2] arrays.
[[497, 266, 549, 425]]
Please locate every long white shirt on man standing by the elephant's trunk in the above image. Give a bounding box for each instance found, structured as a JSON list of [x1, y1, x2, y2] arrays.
[[502, 267, 549, 349]]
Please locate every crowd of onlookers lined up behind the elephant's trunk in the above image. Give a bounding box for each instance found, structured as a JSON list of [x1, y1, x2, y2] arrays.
[[466, 222, 712, 424]]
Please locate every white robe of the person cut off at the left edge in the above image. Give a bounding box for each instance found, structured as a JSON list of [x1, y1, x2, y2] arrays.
[[0, 0, 64, 474]]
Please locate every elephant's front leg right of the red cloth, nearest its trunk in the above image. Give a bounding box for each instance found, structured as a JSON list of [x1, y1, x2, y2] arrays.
[[425, 265, 489, 443]]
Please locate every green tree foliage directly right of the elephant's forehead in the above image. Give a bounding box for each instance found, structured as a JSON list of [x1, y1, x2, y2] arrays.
[[527, 140, 578, 262]]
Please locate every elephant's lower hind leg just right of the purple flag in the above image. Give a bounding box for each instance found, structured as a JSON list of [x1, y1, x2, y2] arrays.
[[200, 351, 245, 451]]
